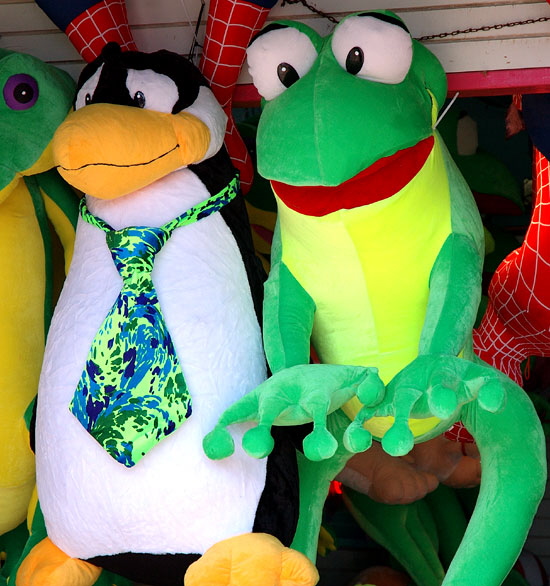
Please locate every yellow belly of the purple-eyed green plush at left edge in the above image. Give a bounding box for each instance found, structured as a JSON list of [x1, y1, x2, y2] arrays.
[[0, 181, 45, 534]]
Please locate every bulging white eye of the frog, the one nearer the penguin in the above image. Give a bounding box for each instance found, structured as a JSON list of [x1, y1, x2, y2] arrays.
[[247, 23, 317, 100]]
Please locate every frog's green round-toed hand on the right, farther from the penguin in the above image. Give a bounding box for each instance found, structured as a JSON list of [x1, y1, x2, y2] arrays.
[[345, 355, 506, 456]]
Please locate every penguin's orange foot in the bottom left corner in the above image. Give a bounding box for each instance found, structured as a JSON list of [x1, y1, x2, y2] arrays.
[[15, 537, 101, 586]]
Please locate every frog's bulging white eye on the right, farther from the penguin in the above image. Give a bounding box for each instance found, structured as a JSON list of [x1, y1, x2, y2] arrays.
[[332, 12, 413, 84]]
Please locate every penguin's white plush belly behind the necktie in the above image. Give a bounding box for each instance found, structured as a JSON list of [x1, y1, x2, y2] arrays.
[[36, 179, 266, 559]]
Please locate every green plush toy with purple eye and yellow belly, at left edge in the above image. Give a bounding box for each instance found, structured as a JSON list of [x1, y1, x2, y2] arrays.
[[0, 49, 78, 578]]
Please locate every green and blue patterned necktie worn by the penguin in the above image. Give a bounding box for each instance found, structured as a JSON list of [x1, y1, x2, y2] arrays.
[[70, 177, 238, 467]]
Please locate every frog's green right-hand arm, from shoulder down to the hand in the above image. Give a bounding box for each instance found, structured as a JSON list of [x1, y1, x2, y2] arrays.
[[419, 139, 483, 356]]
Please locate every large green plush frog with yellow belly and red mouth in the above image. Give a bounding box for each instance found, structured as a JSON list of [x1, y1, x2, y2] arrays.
[[205, 10, 546, 586]]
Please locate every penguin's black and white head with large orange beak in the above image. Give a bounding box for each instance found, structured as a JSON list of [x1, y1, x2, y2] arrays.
[[53, 43, 234, 199]]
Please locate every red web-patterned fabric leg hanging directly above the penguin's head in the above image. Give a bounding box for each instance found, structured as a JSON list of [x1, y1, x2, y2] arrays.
[[65, 0, 137, 63]]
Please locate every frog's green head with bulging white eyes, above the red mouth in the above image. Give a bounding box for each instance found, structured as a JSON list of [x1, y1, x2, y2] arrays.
[[247, 10, 447, 186]]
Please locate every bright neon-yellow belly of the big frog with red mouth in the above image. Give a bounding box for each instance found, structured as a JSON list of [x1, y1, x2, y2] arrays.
[[277, 138, 451, 437]]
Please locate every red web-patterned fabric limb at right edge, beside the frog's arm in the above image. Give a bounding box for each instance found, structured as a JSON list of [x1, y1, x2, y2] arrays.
[[474, 148, 550, 384]]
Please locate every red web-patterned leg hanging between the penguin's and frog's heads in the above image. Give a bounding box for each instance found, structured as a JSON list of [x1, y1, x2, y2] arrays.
[[199, 0, 269, 193]]
